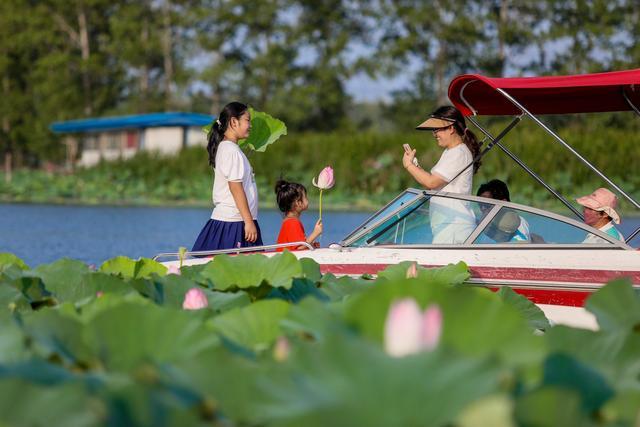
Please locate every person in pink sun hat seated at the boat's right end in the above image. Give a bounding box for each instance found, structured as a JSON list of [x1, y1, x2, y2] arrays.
[[576, 188, 624, 243]]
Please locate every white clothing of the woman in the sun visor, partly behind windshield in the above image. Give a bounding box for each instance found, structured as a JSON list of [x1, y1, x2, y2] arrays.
[[429, 144, 476, 244]]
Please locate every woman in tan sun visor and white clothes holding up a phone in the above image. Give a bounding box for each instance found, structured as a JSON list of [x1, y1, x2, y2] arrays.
[[402, 106, 480, 244]]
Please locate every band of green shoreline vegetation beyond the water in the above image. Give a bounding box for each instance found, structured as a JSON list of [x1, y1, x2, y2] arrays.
[[0, 125, 640, 215]]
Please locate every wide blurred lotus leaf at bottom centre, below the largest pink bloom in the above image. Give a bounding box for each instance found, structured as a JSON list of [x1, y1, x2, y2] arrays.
[[172, 334, 501, 427]]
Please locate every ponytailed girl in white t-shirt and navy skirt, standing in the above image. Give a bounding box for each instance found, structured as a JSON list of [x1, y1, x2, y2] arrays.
[[192, 102, 262, 251]]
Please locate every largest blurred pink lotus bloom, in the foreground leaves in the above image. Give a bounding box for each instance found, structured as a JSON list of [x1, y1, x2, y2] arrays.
[[384, 298, 442, 357]]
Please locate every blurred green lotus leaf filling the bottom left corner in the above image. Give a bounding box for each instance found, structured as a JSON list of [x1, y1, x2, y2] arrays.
[[0, 379, 98, 427]]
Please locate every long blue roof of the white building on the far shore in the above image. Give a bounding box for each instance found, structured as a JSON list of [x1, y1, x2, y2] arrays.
[[50, 112, 214, 133]]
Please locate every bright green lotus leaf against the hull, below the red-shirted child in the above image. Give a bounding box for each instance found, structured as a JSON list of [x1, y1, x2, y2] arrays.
[[201, 251, 303, 290]]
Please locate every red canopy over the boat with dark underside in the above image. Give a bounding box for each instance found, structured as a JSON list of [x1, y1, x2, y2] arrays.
[[449, 69, 640, 116]]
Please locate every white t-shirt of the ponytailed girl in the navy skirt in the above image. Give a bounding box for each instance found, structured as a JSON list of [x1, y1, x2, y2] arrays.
[[211, 140, 258, 222]]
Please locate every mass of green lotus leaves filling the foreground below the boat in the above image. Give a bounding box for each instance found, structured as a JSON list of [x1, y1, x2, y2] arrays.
[[0, 252, 640, 427]]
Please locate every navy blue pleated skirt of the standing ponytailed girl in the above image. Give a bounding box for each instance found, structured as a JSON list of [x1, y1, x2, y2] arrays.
[[191, 219, 262, 251]]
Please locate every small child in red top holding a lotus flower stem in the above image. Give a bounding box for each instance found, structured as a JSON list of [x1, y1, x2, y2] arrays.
[[275, 179, 322, 251]]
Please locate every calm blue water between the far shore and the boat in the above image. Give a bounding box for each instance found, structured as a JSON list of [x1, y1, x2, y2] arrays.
[[0, 204, 640, 267]]
